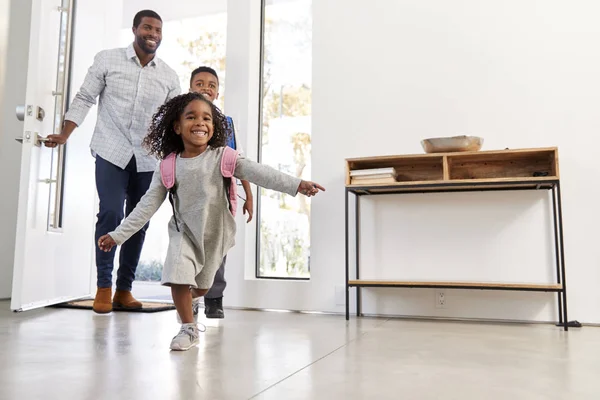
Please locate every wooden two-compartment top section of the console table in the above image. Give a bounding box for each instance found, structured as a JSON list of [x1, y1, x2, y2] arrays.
[[346, 147, 559, 192]]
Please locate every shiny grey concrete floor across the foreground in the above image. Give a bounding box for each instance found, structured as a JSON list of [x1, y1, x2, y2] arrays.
[[0, 302, 600, 400]]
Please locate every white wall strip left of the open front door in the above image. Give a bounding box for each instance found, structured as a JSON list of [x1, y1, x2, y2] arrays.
[[0, 0, 31, 299]]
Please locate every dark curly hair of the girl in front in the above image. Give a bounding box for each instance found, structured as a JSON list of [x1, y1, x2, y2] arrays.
[[143, 92, 231, 160]]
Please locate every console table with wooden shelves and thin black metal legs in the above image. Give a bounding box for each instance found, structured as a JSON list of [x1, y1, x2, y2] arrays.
[[345, 148, 574, 331]]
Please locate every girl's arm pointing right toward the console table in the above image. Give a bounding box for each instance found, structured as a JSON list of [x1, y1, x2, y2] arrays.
[[233, 156, 325, 196]]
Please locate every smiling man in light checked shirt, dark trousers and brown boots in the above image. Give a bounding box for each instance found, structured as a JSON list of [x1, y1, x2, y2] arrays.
[[46, 10, 181, 313]]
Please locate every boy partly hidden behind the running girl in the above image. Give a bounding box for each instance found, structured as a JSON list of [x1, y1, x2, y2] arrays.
[[190, 66, 253, 319]]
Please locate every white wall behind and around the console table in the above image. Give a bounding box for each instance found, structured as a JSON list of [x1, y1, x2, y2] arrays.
[[225, 0, 600, 323]]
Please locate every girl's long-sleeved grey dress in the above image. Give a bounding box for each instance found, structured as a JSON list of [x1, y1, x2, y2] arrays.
[[109, 147, 301, 289]]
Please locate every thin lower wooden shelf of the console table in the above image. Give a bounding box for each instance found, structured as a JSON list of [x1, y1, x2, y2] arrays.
[[348, 279, 563, 292]]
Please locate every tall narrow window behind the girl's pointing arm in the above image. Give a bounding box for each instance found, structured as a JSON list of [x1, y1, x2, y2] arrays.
[[256, 0, 312, 279]]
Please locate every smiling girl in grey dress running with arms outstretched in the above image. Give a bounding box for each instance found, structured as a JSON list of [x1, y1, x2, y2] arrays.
[[98, 93, 325, 350]]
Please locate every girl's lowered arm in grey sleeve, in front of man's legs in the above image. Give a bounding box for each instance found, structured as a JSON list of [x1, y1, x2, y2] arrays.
[[98, 166, 167, 251]]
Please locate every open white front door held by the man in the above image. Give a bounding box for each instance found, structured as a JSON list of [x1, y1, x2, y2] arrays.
[[11, 0, 96, 311]]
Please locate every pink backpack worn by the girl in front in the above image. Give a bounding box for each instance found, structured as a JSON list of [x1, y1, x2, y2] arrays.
[[160, 146, 238, 232]]
